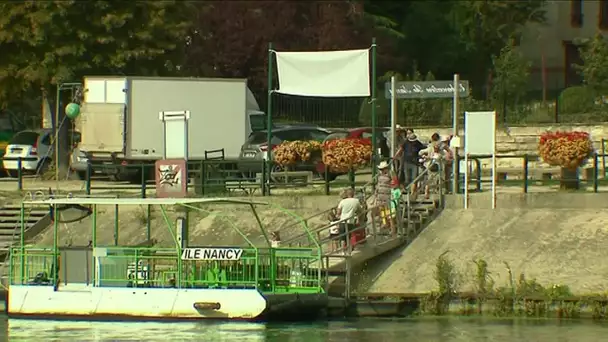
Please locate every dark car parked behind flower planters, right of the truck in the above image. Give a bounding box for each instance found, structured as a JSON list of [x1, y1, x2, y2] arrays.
[[238, 126, 331, 176]]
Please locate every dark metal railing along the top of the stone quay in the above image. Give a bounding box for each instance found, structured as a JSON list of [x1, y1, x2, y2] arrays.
[[4, 151, 608, 198]]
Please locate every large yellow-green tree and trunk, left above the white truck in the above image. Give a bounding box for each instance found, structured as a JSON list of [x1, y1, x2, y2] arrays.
[[0, 1, 191, 173]]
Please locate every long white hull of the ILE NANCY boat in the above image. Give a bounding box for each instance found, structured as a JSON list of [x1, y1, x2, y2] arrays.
[[7, 285, 267, 320]]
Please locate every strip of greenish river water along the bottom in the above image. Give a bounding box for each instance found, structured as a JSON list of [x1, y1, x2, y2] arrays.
[[0, 317, 608, 342]]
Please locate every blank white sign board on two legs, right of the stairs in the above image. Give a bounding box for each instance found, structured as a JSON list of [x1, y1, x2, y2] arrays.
[[464, 112, 496, 209]]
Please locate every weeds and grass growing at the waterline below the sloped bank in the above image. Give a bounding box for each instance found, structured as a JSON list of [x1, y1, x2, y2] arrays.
[[418, 252, 608, 320]]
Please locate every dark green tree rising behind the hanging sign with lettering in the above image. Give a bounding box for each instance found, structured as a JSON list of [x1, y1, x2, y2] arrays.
[[403, 0, 546, 90]]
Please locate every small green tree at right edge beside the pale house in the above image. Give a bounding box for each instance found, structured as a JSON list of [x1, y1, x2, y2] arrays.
[[575, 32, 608, 92]]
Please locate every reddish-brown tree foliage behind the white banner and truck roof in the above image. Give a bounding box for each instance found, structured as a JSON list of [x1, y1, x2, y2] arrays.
[[183, 0, 390, 97]]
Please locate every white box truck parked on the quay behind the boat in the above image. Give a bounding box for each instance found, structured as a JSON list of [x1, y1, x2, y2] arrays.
[[77, 76, 266, 179]]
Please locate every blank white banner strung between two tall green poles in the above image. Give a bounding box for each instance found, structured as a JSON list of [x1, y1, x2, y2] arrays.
[[276, 49, 370, 97]]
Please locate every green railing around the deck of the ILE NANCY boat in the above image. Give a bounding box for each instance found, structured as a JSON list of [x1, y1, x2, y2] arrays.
[[9, 246, 324, 292]]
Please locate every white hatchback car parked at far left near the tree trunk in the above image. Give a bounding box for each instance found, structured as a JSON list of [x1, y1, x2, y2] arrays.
[[2, 128, 80, 177]]
